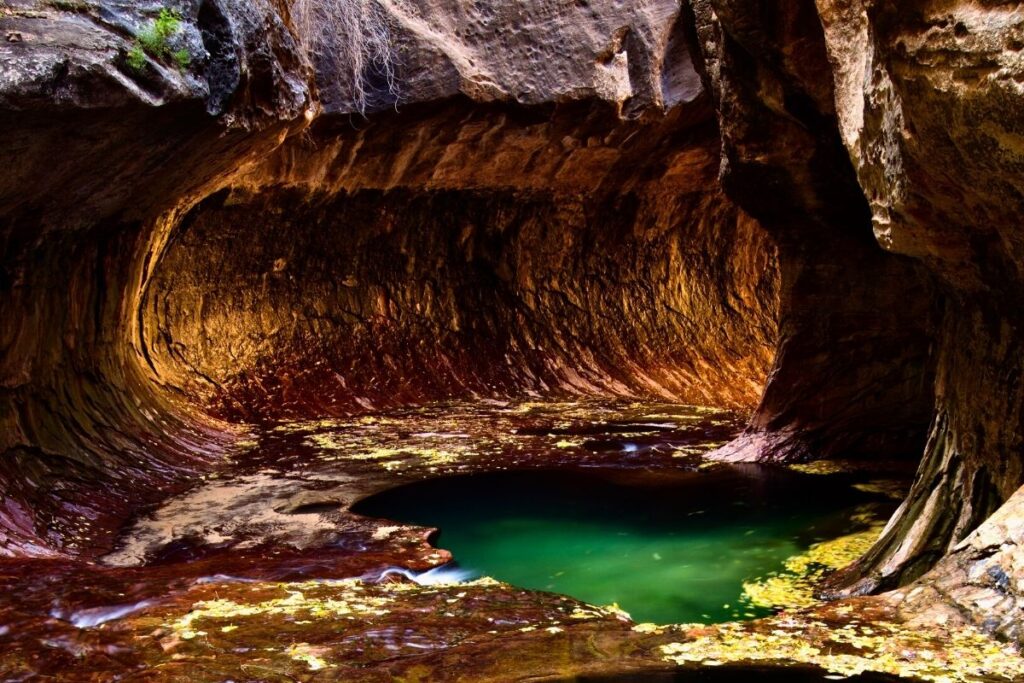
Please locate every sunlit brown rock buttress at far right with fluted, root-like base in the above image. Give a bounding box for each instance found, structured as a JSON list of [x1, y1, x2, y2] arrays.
[[806, 2, 1024, 590]]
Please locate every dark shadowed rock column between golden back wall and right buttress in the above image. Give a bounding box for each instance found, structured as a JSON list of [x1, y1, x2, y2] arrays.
[[692, 1, 934, 461]]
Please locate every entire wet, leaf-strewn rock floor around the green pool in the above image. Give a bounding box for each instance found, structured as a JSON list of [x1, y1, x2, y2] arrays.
[[0, 401, 1024, 682]]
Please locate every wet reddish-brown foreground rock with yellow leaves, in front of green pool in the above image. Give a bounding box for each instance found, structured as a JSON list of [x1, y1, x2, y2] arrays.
[[2, 561, 1024, 683]]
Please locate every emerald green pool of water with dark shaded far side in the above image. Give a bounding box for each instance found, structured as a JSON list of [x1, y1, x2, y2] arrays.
[[353, 466, 887, 624]]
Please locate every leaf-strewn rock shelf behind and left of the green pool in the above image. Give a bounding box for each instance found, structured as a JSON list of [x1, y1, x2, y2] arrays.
[[100, 400, 738, 568]]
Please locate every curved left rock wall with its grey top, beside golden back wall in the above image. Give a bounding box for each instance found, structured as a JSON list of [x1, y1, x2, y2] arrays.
[[0, 2, 311, 555]]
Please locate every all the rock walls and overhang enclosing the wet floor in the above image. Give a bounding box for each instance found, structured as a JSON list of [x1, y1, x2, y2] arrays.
[[0, 0, 1024, 655]]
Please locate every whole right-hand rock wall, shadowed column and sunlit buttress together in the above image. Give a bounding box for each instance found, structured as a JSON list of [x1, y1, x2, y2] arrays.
[[692, 0, 1024, 640]]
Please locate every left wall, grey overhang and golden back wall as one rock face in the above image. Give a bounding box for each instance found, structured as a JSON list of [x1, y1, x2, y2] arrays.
[[0, 0, 778, 556]]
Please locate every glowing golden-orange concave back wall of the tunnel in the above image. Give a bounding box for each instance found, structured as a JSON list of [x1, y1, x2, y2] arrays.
[[143, 102, 777, 420]]
